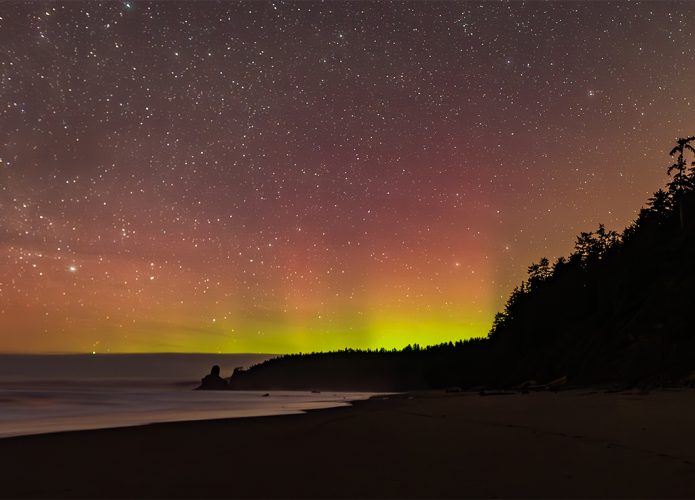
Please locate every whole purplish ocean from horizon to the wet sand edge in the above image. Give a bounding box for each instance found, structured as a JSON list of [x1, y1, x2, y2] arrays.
[[0, 354, 372, 437]]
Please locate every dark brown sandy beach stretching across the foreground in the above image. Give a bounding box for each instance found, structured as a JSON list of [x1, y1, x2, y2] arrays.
[[0, 390, 695, 498]]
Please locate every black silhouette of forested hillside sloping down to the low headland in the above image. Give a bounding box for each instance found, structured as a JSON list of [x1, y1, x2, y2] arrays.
[[222, 137, 695, 391]]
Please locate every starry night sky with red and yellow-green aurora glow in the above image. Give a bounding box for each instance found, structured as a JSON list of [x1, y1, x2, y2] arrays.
[[0, 0, 695, 353]]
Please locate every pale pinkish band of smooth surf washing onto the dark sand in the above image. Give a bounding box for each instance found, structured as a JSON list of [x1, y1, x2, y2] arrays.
[[0, 383, 379, 439]]
